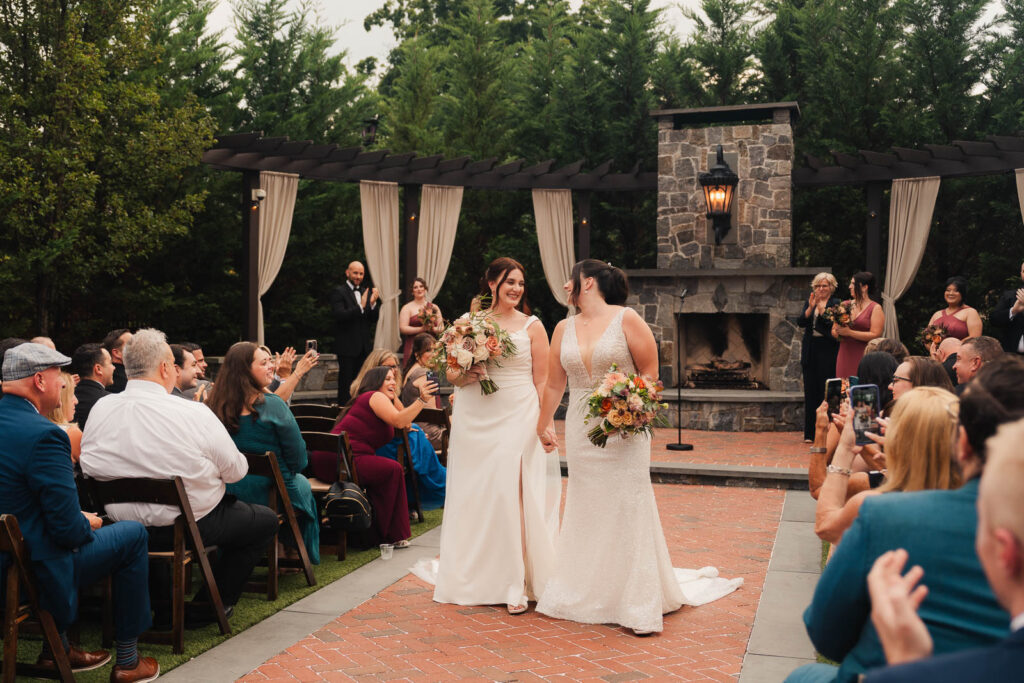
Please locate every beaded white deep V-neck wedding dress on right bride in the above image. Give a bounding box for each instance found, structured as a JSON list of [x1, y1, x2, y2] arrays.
[[537, 308, 742, 631]]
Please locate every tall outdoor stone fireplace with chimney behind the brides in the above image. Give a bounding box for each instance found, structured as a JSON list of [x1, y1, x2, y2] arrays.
[[629, 102, 821, 431]]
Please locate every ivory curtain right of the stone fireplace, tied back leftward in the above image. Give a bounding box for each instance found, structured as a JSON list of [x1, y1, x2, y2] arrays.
[[874, 176, 939, 339]]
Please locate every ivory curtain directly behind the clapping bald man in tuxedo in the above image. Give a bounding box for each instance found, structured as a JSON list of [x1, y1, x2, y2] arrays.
[[359, 180, 401, 349]]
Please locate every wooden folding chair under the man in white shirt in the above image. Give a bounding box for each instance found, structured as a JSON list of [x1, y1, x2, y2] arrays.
[[89, 476, 231, 654]]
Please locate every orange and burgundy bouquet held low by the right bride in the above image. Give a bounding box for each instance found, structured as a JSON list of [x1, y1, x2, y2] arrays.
[[584, 364, 669, 449]]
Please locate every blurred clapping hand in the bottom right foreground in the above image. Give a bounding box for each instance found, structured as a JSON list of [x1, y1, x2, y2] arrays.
[[867, 548, 934, 665]]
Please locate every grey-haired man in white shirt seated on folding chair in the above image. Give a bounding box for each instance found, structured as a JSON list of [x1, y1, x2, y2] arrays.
[[81, 330, 278, 621]]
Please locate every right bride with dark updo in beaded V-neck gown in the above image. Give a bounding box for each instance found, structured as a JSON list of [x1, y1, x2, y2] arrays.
[[537, 259, 742, 635]]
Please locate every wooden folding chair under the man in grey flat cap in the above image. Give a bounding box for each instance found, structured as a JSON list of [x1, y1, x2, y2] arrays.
[[0, 515, 75, 683]]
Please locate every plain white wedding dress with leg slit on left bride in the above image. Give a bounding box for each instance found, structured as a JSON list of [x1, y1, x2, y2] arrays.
[[412, 316, 561, 605]]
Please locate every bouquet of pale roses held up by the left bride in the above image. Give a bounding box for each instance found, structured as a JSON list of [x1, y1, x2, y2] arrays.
[[432, 312, 516, 395]]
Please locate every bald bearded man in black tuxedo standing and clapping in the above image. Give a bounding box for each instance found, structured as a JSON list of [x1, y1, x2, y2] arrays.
[[331, 261, 380, 405]]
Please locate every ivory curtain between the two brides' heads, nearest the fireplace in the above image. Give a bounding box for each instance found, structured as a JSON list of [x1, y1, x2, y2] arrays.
[[534, 185, 575, 306]]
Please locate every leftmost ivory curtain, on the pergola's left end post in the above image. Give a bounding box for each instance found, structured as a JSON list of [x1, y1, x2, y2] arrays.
[[256, 171, 299, 344]]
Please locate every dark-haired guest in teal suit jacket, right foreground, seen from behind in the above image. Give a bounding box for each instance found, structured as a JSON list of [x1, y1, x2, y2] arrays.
[[786, 357, 1024, 683]]
